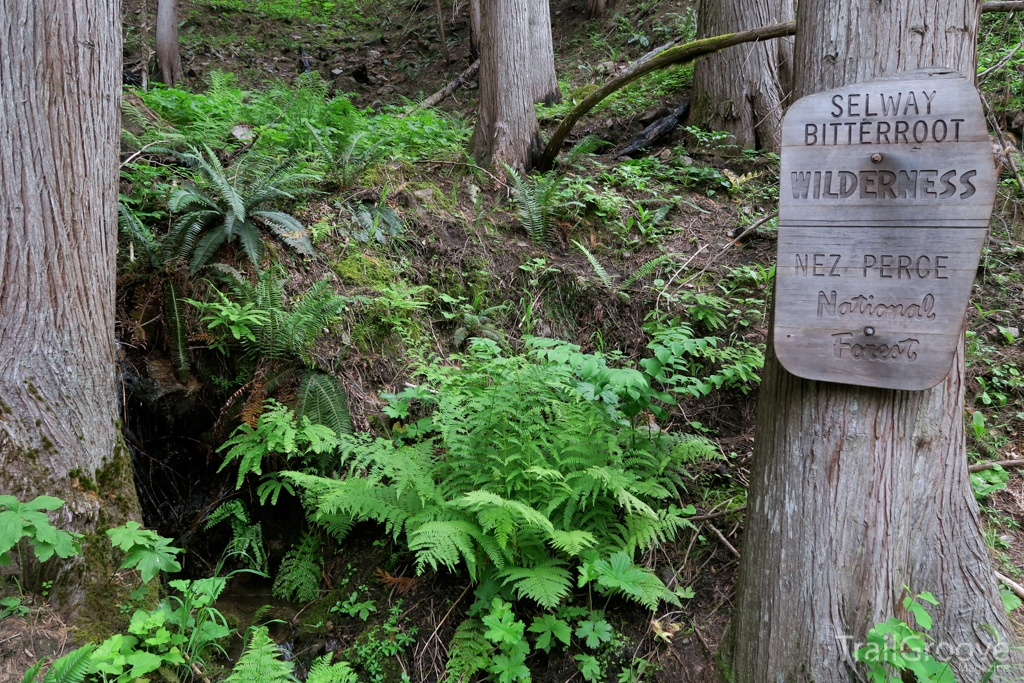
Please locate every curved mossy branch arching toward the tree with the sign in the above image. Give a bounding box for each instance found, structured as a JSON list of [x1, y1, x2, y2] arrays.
[[538, 22, 797, 171]]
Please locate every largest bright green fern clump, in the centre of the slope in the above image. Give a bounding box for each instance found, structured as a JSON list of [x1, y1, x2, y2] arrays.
[[285, 339, 711, 607]]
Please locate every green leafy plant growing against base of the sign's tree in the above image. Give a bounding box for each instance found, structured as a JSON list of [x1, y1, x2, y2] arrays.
[[854, 593, 956, 683]]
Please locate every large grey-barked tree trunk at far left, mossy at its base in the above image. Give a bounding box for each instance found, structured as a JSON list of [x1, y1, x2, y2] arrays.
[[0, 0, 138, 611]]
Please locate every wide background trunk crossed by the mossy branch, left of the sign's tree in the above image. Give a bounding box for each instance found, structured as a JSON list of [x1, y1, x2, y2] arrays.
[[690, 0, 794, 152]]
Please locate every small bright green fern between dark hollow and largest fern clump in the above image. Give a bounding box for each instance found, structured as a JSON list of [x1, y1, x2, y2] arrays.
[[217, 398, 338, 488]]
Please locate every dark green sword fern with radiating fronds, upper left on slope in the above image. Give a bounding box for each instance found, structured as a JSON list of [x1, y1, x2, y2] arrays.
[[163, 146, 318, 272]]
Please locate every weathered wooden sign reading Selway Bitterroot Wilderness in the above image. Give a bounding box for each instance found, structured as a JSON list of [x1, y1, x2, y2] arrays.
[[774, 69, 996, 390]]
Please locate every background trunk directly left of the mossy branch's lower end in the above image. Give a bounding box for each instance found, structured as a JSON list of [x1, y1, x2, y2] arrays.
[[469, 0, 543, 173]]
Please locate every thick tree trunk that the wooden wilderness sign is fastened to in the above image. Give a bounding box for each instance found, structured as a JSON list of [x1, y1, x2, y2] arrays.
[[722, 0, 1021, 683]]
